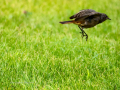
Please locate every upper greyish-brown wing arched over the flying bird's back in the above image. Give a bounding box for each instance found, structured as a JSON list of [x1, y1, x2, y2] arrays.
[[70, 9, 100, 20]]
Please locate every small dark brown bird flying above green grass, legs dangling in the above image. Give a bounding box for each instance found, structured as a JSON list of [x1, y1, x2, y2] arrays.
[[60, 9, 111, 41]]
